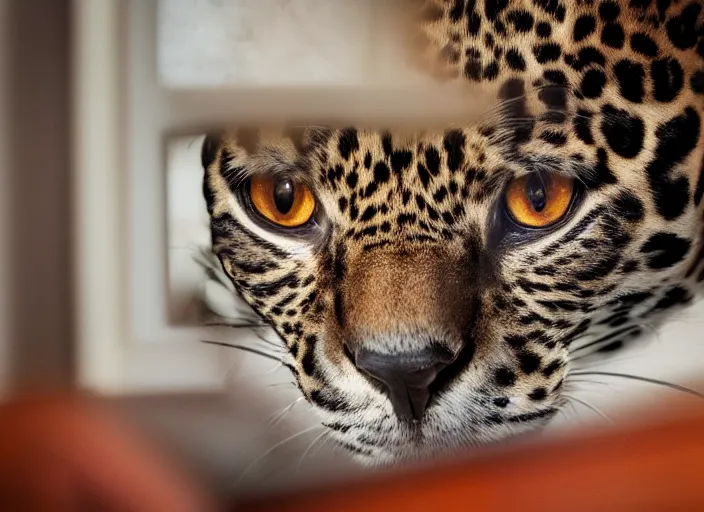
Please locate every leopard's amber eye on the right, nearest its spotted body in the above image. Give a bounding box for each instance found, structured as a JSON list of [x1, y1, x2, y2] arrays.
[[506, 173, 574, 228]]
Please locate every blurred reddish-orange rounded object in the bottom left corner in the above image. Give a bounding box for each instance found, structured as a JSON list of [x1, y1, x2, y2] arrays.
[[0, 397, 220, 512]]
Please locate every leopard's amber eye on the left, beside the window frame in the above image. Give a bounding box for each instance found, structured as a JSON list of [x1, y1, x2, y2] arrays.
[[249, 176, 315, 228]]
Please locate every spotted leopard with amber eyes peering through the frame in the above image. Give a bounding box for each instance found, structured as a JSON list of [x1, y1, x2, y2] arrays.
[[201, 0, 704, 466]]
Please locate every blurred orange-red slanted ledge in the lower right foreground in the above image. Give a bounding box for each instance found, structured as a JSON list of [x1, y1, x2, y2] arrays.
[[234, 405, 704, 512]]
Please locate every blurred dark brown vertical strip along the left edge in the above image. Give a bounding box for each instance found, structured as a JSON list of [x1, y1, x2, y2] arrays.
[[0, 0, 74, 393]]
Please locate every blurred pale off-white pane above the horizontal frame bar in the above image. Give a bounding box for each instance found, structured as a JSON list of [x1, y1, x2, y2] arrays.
[[158, 0, 427, 87]]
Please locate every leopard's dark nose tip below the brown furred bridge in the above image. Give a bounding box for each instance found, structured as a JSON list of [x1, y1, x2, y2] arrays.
[[355, 347, 454, 420]]
